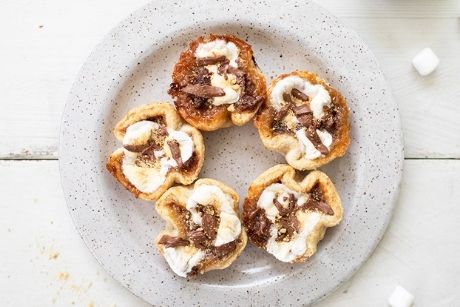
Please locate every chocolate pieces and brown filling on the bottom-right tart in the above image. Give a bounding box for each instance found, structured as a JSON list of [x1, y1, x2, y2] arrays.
[[243, 183, 334, 247]]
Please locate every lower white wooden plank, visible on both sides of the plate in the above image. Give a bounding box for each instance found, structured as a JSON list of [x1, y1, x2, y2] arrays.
[[0, 160, 460, 307]]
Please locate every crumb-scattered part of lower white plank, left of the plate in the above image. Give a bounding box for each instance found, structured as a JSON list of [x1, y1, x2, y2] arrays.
[[0, 161, 150, 307]]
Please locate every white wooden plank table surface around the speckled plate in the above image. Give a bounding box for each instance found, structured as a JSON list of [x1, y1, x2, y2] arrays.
[[0, 0, 460, 306]]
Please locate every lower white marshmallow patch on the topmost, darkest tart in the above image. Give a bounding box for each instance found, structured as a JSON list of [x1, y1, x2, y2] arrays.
[[206, 65, 241, 106]]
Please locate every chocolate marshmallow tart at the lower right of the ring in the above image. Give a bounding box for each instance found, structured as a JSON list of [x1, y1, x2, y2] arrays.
[[243, 164, 342, 263]]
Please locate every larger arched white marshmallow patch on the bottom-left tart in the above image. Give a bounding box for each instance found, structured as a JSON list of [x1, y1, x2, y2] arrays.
[[186, 184, 241, 246]]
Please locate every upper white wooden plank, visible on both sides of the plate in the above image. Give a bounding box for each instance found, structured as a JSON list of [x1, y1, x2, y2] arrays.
[[0, 0, 460, 159]]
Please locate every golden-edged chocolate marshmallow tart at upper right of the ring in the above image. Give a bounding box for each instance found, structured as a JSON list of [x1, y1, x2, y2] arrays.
[[254, 71, 350, 170]]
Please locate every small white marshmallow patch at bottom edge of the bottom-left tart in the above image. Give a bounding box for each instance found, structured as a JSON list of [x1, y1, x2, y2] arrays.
[[164, 246, 205, 277]]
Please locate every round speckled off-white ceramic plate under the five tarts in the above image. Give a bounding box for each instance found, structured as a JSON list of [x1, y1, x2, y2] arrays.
[[60, 0, 403, 306]]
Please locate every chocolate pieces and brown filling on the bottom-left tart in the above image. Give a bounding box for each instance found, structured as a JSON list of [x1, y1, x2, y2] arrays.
[[158, 203, 240, 275]]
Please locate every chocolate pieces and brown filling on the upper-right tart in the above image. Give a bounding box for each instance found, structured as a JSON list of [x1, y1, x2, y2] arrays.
[[270, 88, 344, 154]]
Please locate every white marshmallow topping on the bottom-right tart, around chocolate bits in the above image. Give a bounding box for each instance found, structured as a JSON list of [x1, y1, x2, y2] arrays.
[[257, 183, 321, 262]]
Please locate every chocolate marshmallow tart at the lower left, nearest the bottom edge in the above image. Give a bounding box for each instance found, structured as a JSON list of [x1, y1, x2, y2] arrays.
[[156, 179, 247, 277]]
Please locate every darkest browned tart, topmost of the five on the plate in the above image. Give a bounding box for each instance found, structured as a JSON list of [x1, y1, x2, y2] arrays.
[[168, 34, 267, 131]]
